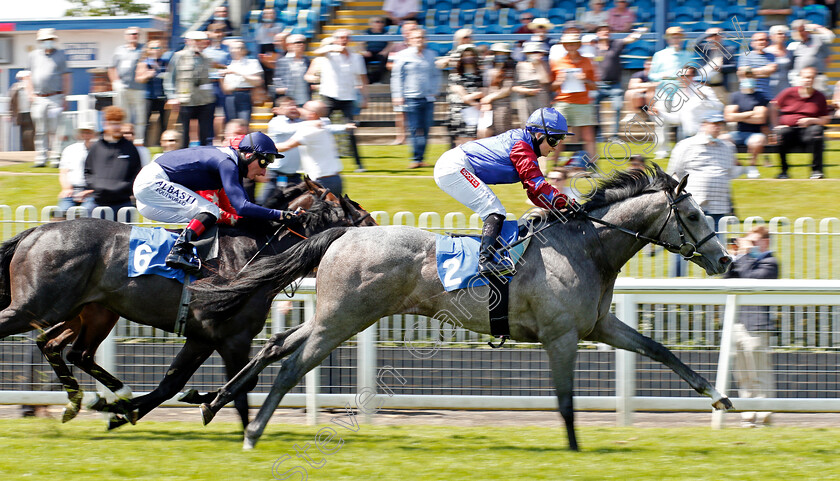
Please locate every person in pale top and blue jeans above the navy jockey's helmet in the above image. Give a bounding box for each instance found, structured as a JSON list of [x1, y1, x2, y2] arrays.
[[222, 40, 262, 124]]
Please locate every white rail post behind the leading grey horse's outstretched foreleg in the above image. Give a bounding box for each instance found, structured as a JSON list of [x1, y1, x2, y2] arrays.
[[615, 294, 639, 426]]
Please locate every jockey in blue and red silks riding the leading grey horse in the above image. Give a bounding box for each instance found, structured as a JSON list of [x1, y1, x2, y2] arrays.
[[435, 108, 580, 275]]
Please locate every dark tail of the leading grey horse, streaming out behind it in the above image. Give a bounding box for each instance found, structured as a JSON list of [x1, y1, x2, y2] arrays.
[[190, 227, 349, 319]]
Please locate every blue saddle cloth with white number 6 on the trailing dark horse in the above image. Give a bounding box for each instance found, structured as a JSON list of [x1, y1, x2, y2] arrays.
[[128, 227, 189, 283]]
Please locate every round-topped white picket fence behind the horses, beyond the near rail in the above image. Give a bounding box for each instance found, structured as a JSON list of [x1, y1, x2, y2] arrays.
[[0, 205, 840, 279]]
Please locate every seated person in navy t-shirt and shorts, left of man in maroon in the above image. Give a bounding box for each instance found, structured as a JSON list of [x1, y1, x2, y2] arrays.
[[723, 78, 770, 179]]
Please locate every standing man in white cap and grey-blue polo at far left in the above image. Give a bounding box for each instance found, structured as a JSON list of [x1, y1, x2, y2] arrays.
[[26, 28, 71, 167]]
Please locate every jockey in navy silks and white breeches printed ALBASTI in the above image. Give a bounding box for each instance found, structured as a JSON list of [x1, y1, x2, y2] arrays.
[[134, 132, 297, 273]]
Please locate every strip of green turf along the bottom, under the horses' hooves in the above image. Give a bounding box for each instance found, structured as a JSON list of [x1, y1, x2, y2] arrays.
[[0, 419, 840, 481]]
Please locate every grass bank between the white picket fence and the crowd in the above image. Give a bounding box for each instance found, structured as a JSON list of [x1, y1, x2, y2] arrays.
[[0, 144, 840, 219]]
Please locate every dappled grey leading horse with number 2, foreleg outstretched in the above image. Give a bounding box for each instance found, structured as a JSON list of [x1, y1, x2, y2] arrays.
[[195, 166, 732, 450]]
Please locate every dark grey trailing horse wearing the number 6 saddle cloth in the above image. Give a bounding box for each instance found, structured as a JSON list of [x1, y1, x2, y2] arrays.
[[0, 184, 375, 427]]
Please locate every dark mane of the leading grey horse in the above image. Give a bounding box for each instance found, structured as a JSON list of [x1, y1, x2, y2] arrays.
[[583, 164, 678, 212]]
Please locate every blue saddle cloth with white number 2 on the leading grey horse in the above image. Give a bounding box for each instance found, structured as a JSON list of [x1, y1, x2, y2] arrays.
[[435, 220, 527, 292]]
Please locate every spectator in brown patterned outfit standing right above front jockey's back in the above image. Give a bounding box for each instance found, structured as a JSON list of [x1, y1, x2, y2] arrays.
[[479, 43, 516, 137]]
